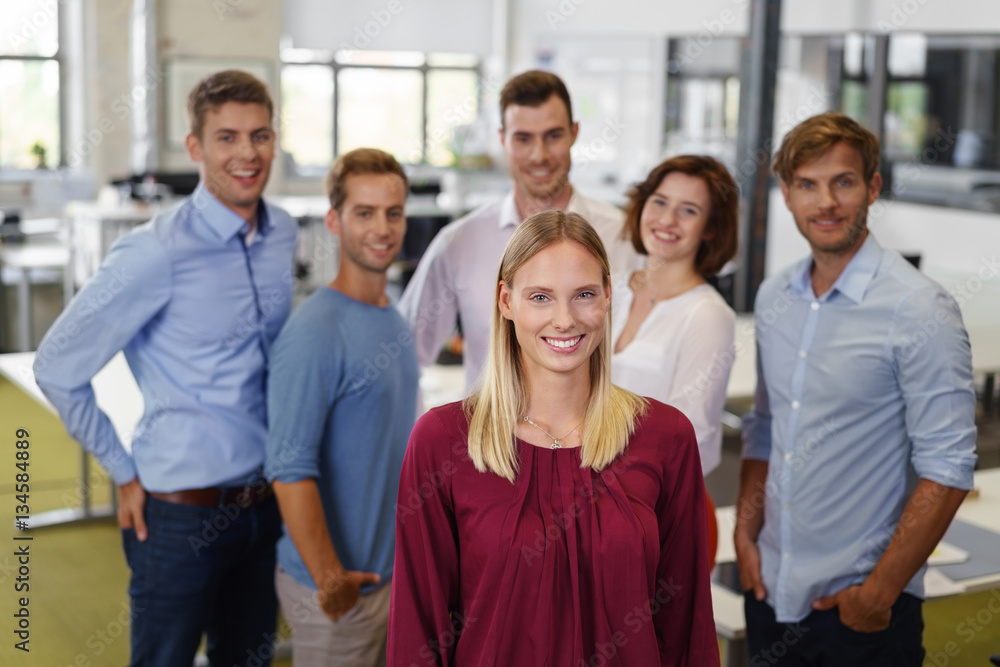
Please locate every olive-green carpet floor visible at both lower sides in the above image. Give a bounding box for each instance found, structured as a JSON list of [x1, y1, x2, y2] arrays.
[[0, 377, 1000, 667]]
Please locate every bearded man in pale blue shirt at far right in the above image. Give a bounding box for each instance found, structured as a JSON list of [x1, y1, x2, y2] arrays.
[[734, 112, 976, 667]]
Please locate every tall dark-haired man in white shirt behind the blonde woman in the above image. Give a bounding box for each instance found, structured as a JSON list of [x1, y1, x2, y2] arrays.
[[399, 70, 641, 389]]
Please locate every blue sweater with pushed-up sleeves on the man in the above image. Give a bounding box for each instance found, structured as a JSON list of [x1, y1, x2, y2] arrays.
[[265, 287, 420, 592]]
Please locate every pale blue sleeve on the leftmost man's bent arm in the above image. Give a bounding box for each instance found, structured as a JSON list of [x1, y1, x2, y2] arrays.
[[34, 231, 171, 485]]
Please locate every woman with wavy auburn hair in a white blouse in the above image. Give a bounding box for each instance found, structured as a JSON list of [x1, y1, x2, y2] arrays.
[[611, 155, 739, 475]]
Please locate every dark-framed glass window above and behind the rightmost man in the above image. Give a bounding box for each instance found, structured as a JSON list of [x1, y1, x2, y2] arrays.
[[839, 34, 1000, 212]]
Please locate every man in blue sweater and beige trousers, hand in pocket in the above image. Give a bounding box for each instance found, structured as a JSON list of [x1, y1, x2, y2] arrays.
[[266, 148, 419, 667]]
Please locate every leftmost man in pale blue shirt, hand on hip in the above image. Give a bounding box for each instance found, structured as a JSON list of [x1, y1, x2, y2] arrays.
[[35, 70, 296, 667]]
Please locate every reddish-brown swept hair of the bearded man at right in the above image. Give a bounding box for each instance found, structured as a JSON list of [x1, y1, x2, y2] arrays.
[[771, 111, 879, 184]]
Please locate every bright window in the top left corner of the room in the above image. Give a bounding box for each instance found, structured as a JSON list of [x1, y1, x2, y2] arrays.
[[0, 1, 62, 169]]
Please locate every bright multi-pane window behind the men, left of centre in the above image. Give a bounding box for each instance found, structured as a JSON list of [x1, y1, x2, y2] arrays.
[[281, 49, 480, 176]]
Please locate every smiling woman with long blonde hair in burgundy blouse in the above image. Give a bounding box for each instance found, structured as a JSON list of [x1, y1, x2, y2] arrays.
[[388, 211, 719, 667]]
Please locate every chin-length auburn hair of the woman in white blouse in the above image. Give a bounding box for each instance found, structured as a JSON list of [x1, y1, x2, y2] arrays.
[[621, 155, 740, 276]]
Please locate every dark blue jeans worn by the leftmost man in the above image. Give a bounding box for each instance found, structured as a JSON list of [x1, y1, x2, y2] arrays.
[[122, 496, 281, 667]]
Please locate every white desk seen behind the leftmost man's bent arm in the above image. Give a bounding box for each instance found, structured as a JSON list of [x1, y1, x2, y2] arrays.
[[0, 352, 143, 528]]
